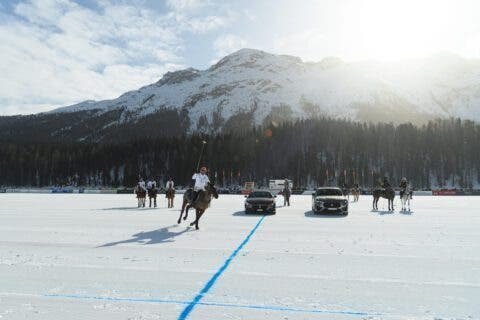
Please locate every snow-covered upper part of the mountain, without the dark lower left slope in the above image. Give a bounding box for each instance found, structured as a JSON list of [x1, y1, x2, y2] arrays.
[[53, 49, 480, 130]]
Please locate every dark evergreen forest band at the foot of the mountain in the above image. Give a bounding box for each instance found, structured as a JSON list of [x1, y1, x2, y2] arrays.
[[0, 118, 480, 189]]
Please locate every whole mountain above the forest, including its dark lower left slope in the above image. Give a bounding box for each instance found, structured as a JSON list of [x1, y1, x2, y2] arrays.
[[0, 49, 480, 140]]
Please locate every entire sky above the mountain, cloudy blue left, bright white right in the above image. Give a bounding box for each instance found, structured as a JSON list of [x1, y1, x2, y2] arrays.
[[0, 0, 480, 115]]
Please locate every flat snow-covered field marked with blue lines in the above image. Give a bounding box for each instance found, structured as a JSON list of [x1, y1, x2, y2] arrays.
[[0, 194, 480, 320]]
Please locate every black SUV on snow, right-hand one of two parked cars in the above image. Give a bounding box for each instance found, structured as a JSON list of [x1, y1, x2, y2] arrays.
[[312, 187, 348, 216]]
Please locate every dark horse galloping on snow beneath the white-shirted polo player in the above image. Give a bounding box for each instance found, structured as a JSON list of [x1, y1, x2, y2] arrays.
[[177, 182, 218, 230]]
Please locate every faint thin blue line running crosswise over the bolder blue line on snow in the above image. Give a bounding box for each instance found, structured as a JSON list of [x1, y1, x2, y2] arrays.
[[44, 294, 383, 316]]
